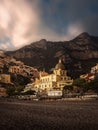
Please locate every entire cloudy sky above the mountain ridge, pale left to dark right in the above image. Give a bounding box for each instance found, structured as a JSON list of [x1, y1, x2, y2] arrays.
[[0, 0, 98, 50]]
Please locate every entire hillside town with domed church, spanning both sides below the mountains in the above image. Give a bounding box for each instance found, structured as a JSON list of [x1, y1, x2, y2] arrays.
[[0, 51, 98, 97]]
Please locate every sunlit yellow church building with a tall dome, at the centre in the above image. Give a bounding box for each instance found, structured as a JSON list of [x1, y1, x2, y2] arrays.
[[34, 60, 73, 92]]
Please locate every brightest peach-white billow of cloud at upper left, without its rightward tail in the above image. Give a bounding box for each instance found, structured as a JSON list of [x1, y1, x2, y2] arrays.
[[0, 0, 40, 49]]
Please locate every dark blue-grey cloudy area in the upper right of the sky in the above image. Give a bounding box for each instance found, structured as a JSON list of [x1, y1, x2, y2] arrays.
[[42, 0, 98, 34]]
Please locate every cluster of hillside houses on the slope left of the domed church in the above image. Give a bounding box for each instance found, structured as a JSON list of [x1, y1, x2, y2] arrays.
[[0, 51, 39, 96]]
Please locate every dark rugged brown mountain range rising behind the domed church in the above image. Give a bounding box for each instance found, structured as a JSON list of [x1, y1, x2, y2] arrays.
[[6, 32, 98, 77]]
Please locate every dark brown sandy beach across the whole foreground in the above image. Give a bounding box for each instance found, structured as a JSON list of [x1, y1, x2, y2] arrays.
[[0, 100, 98, 130]]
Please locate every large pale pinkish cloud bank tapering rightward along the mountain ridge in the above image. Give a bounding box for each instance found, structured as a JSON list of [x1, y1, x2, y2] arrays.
[[0, 0, 78, 50]]
